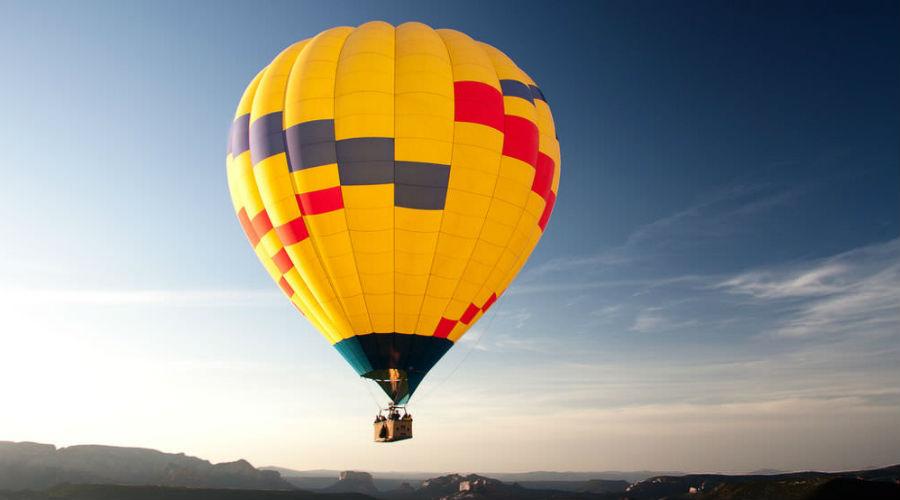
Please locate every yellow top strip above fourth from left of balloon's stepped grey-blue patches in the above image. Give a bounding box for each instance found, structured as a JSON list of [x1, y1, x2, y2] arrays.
[[334, 21, 394, 140]]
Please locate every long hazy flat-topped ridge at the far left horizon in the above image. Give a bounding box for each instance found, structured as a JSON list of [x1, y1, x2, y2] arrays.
[[0, 441, 294, 490]]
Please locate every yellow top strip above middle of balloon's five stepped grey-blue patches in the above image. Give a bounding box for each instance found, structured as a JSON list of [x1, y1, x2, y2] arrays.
[[284, 26, 353, 127]]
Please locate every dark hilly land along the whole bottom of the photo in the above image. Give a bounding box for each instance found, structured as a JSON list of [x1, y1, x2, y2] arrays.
[[0, 442, 900, 500]]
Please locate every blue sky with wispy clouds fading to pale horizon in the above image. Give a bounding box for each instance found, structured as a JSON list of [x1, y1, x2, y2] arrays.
[[0, 2, 900, 471]]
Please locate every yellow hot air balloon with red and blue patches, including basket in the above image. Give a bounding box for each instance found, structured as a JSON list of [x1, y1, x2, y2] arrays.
[[226, 21, 560, 440]]
